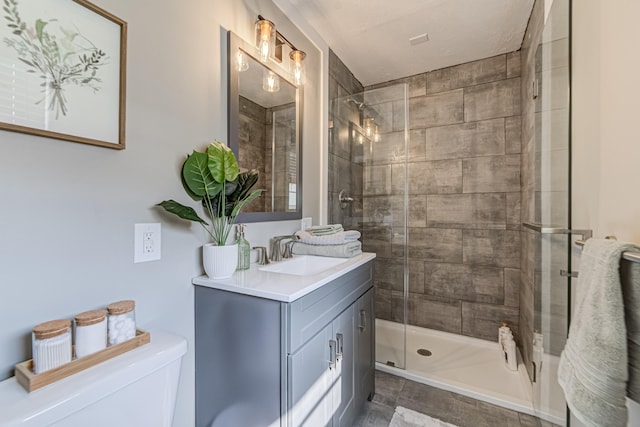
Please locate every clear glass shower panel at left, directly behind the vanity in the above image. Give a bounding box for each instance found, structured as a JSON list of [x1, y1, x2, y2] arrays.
[[329, 84, 408, 368]]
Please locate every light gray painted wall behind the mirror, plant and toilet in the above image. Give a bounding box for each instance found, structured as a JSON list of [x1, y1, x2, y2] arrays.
[[0, 0, 324, 426]]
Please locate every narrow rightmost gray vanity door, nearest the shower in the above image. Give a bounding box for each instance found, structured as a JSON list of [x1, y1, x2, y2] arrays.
[[356, 288, 375, 410]]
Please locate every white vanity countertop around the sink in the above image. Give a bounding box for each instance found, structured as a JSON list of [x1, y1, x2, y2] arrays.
[[192, 252, 376, 302]]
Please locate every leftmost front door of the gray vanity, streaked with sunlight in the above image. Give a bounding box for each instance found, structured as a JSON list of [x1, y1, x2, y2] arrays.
[[288, 324, 335, 427]]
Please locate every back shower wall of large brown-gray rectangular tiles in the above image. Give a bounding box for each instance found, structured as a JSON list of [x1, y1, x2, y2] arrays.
[[363, 52, 521, 340]]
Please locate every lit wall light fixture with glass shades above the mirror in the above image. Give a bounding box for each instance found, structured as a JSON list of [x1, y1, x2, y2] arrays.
[[256, 15, 307, 86]]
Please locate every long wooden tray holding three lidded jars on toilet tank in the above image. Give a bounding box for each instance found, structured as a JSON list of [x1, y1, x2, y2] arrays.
[[15, 329, 151, 393]]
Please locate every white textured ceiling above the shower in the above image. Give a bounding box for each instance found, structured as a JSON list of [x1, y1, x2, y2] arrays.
[[278, 0, 533, 86]]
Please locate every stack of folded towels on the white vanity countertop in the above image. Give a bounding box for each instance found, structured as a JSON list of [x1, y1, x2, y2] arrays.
[[292, 224, 362, 258]]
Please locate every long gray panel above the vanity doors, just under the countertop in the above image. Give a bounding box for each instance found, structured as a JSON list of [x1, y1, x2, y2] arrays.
[[286, 262, 373, 354]]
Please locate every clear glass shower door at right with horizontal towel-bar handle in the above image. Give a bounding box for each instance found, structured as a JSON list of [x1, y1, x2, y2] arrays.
[[532, 0, 577, 425]]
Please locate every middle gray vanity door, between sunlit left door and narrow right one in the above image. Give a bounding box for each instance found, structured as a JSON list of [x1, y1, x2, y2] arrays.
[[332, 304, 356, 427]]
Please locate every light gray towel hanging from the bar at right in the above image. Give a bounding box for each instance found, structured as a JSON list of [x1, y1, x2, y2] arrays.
[[558, 239, 636, 427]]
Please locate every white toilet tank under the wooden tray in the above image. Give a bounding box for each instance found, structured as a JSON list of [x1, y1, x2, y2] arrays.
[[0, 331, 187, 427]]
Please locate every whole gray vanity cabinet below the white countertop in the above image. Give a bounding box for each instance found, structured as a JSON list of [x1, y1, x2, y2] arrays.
[[195, 262, 374, 427]]
